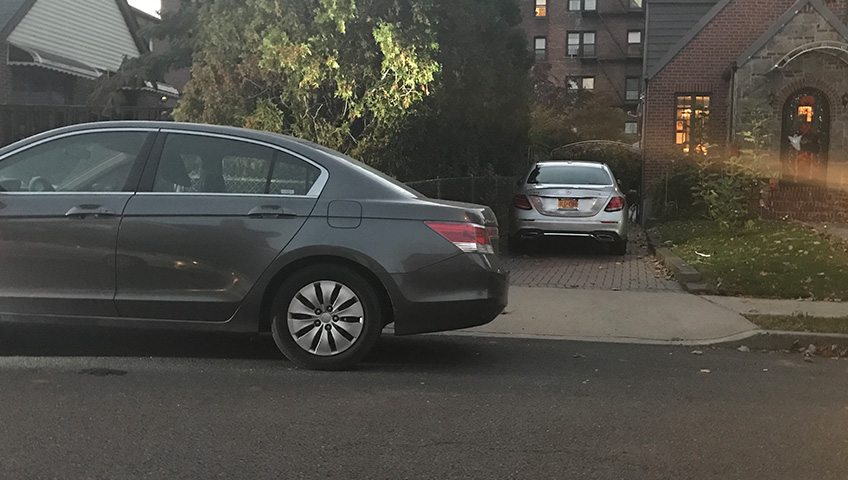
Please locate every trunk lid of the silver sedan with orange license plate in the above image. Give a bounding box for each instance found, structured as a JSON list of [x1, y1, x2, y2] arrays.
[[526, 185, 612, 217]]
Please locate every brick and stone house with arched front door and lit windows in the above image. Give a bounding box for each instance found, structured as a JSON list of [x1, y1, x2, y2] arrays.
[[642, 0, 848, 218]]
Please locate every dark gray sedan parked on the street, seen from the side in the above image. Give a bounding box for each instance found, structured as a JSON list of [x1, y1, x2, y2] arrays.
[[0, 122, 508, 369]]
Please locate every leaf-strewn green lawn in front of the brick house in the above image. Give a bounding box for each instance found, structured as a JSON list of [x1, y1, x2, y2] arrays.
[[657, 220, 848, 301]]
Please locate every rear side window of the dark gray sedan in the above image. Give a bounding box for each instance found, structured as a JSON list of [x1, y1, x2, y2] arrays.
[[153, 134, 320, 195]]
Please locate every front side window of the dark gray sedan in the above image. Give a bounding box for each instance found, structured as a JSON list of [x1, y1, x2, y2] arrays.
[[0, 132, 148, 193]]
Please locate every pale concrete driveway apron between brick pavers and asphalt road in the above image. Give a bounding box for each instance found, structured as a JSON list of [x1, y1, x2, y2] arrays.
[[461, 287, 758, 345]]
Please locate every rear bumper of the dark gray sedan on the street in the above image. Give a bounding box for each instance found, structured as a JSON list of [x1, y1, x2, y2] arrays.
[[392, 254, 509, 335]]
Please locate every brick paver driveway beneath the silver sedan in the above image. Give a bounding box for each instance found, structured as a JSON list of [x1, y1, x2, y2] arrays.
[[505, 229, 680, 291]]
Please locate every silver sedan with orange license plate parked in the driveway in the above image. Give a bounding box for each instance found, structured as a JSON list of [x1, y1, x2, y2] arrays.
[[510, 162, 628, 255]]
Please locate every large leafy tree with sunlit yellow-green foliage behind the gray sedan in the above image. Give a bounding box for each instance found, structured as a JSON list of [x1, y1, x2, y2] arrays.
[[175, 0, 440, 167]]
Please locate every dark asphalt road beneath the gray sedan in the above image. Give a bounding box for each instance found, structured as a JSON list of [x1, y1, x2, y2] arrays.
[[0, 326, 848, 480]]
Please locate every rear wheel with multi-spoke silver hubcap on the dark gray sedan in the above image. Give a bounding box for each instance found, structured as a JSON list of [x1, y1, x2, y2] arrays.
[[271, 264, 383, 370]]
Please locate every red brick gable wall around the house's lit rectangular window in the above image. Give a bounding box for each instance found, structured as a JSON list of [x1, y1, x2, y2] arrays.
[[643, 0, 800, 189]]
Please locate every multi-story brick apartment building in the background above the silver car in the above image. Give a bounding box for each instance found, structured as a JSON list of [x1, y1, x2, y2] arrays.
[[521, 0, 645, 141]]
